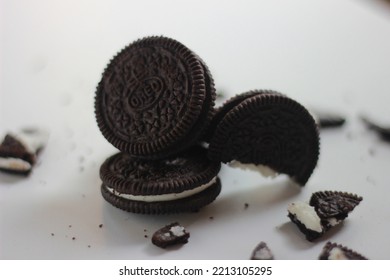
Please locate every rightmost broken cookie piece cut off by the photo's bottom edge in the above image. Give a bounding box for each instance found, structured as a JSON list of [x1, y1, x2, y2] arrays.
[[318, 241, 367, 260]]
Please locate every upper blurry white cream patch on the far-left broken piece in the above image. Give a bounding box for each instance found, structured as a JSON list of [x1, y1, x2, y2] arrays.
[[10, 129, 49, 154]]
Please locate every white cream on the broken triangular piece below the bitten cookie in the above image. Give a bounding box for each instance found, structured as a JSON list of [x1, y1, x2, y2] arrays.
[[288, 202, 322, 232]]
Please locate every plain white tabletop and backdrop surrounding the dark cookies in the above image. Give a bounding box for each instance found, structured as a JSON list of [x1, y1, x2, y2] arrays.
[[0, 0, 390, 259]]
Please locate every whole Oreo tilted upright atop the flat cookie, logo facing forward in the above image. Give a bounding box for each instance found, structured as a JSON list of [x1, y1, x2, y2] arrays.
[[95, 37, 216, 159]]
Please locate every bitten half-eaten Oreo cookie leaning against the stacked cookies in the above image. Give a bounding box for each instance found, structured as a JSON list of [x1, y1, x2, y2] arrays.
[[208, 90, 319, 186]]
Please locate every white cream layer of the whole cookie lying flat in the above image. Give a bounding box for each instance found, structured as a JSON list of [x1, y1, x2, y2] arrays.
[[105, 176, 217, 202]]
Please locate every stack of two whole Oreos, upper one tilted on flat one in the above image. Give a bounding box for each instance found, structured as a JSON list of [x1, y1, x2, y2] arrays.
[[95, 37, 221, 214]]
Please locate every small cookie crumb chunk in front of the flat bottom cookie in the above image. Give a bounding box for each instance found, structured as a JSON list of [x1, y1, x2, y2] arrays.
[[152, 222, 190, 248]]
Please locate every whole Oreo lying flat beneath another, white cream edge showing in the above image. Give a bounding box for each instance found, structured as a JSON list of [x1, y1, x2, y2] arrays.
[[100, 146, 221, 214]]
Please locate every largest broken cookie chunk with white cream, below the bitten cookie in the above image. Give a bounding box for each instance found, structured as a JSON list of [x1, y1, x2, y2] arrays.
[[287, 191, 363, 241]]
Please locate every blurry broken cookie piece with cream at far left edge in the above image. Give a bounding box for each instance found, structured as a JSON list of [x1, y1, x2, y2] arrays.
[[0, 128, 49, 175]]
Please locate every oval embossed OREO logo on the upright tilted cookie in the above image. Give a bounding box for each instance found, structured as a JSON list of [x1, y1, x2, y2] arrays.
[[127, 76, 165, 110]]
